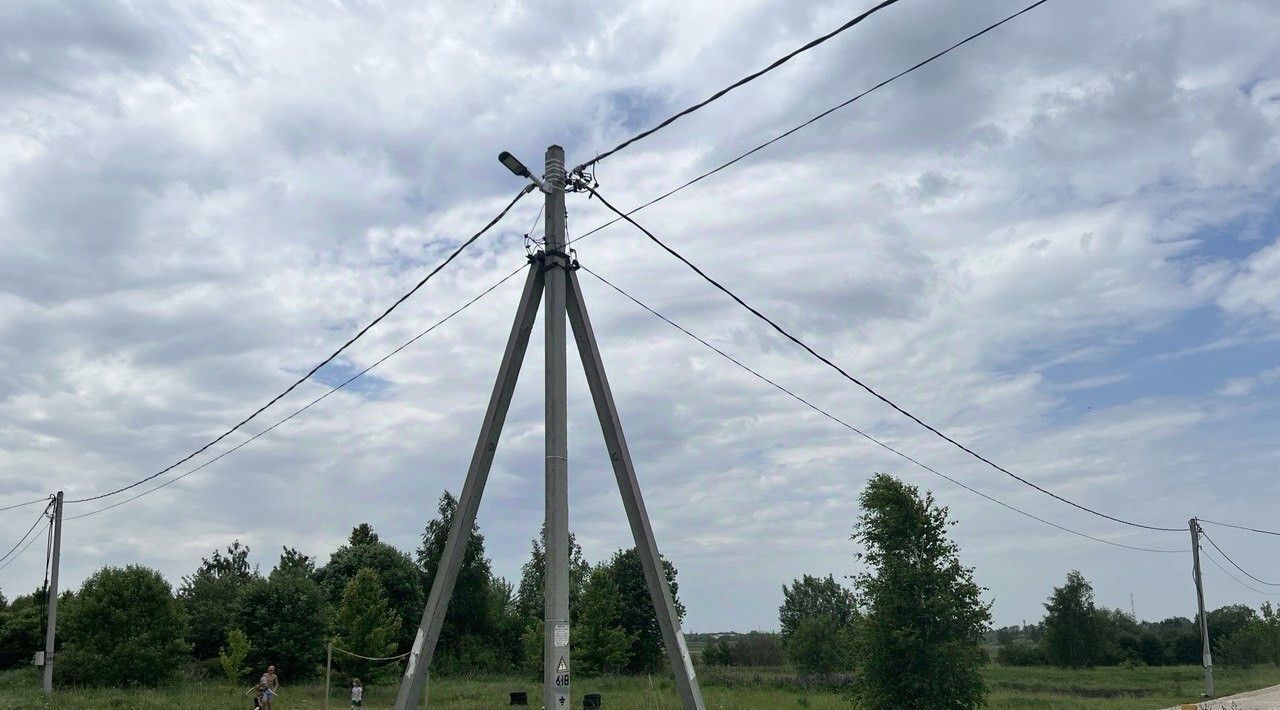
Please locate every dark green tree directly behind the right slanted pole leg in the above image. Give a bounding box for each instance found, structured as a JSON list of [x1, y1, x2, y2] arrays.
[[607, 548, 685, 673]]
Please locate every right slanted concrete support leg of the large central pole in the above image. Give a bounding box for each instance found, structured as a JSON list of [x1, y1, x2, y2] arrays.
[[568, 271, 705, 710]]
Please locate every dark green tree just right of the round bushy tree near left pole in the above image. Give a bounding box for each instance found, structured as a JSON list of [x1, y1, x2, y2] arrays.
[[178, 540, 257, 659]]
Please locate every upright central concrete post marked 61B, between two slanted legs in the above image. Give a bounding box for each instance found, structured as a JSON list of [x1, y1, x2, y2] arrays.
[[543, 146, 572, 710]]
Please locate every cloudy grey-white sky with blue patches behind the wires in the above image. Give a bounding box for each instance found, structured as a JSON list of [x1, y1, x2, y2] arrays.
[[0, 0, 1280, 631]]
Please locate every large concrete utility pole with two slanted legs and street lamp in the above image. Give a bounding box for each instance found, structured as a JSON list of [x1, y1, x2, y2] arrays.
[[394, 146, 705, 710]]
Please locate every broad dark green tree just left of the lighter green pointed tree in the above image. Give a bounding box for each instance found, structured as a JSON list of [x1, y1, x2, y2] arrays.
[[239, 550, 333, 678]]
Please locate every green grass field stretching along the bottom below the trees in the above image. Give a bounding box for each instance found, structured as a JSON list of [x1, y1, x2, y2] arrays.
[[0, 665, 1280, 710]]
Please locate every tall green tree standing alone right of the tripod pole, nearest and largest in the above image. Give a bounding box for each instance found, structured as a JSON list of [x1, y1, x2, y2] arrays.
[[852, 473, 991, 710]]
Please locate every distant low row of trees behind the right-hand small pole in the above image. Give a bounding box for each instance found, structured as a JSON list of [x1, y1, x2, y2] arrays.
[[993, 571, 1280, 668]]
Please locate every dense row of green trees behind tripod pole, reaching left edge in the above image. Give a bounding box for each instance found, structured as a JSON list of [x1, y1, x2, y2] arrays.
[[0, 493, 684, 686]]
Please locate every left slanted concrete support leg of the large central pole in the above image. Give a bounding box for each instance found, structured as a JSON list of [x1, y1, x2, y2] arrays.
[[396, 264, 543, 710]]
